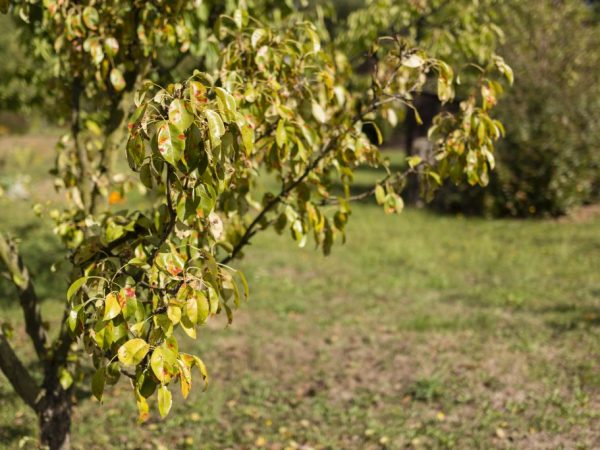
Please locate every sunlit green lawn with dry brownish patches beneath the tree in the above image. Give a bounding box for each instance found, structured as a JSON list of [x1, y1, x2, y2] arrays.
[[0, 135, 600, 450]]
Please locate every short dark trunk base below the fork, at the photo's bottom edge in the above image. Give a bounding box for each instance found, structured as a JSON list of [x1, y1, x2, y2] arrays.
[[38, 385, 72, 450]]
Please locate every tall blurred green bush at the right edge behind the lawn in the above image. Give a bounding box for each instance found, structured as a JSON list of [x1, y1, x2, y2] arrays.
[[436, 0, 600, 216]]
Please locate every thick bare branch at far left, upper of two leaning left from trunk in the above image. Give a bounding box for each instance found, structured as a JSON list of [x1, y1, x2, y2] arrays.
[[0, 233, 47, 360]]
